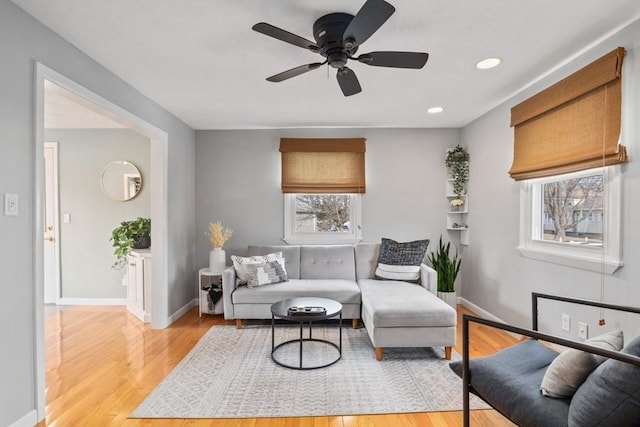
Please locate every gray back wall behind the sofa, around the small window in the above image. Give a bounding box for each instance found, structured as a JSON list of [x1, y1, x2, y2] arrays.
[[196, 129, 459, 267]]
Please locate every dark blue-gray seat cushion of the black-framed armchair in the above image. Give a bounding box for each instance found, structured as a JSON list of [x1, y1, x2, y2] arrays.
[[449, 339, 569, 426]]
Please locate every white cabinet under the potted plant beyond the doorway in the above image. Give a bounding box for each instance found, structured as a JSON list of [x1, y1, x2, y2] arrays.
[[127, 249, 151, 323]]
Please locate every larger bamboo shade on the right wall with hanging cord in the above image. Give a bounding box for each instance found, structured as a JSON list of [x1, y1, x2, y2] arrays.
[[509, 47, 627, 181]]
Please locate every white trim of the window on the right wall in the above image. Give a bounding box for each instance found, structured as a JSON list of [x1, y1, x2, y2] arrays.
[[518, 166, 624, 274]]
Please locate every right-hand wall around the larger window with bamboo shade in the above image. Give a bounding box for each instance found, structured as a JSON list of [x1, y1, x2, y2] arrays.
[[461, 22, 640, 338]]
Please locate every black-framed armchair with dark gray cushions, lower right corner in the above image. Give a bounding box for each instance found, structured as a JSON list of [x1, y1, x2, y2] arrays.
[[450, 293, 640, 427]]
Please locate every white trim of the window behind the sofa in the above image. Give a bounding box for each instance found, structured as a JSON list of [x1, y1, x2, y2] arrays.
[[282, 193, 362, 245]]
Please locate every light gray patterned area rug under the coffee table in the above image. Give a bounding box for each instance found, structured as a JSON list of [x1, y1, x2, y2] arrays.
[[131, 325, 488, 418]]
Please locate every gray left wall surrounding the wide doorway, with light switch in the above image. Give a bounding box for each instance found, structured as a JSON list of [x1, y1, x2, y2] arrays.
[[0, 1, 195, 425]]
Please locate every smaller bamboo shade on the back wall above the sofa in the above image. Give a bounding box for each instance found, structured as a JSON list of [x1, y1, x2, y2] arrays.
[[280, 138, 365, 194]]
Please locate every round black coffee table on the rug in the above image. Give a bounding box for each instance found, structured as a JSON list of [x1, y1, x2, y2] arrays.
[[271, 297, 342, 370]]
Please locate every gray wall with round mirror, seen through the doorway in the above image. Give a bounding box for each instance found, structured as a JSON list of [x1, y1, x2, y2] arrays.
[[45, 129, 151, 298]]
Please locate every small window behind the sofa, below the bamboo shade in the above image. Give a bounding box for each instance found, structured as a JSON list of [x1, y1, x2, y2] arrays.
[[284, 193, 361, 244]]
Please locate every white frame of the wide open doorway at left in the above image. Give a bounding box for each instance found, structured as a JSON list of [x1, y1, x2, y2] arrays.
[[32, 61, 170, 420]]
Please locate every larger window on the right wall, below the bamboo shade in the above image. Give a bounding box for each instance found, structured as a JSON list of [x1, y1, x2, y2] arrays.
[[518, 166, 622, 274]]
